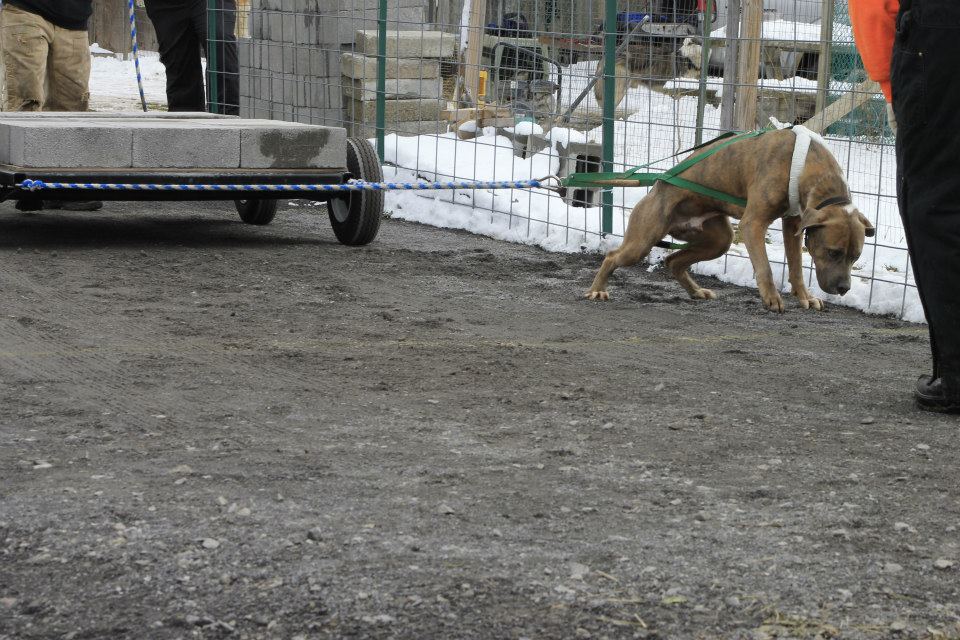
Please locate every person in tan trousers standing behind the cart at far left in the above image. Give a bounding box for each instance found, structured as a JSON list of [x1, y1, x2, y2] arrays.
[[0, 0, 103, 211]]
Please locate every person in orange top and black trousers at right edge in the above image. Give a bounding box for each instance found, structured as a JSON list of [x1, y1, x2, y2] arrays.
[[849, 0, 960, 413]]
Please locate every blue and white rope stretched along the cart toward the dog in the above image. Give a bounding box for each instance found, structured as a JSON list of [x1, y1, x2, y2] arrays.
[[17, 176, 556, 193]]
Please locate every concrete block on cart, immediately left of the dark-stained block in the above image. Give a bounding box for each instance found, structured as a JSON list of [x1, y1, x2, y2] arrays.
[[132, 120, 242, 168]]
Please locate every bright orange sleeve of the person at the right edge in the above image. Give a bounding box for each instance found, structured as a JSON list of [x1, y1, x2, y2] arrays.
[[849, 0, 900, 102]]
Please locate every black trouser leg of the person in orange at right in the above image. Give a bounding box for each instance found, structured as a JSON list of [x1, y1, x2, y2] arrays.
[[891, 0, 960, 395]]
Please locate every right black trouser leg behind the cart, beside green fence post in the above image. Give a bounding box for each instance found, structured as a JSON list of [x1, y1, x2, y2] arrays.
[[191, 0, 240, 115]]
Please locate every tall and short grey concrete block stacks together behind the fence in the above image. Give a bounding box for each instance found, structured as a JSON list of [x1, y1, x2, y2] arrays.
[[239, 0, 457, 136]]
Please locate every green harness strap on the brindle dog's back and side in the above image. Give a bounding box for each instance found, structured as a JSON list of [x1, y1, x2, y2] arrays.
[[562, 128, 771, 207]]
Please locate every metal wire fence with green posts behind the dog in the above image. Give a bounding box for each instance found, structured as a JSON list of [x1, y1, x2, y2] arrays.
[[209, 0, 922, 320]]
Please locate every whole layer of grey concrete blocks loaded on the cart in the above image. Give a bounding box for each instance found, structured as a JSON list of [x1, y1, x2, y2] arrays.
[[0, 113, 346, 169]]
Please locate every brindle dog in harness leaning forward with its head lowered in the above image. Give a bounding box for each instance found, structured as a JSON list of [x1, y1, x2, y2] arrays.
[[587, 129, 874, 312]]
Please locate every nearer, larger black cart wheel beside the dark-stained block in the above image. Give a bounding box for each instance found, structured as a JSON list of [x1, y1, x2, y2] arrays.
[[327, 138, 383, 247]]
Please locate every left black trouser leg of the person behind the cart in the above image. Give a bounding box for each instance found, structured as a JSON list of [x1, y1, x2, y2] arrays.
[[146, 0, 206, 111]]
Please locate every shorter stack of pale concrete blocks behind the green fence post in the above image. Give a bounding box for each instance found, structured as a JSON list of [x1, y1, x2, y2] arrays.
[[340, 29, 456, 137]]
